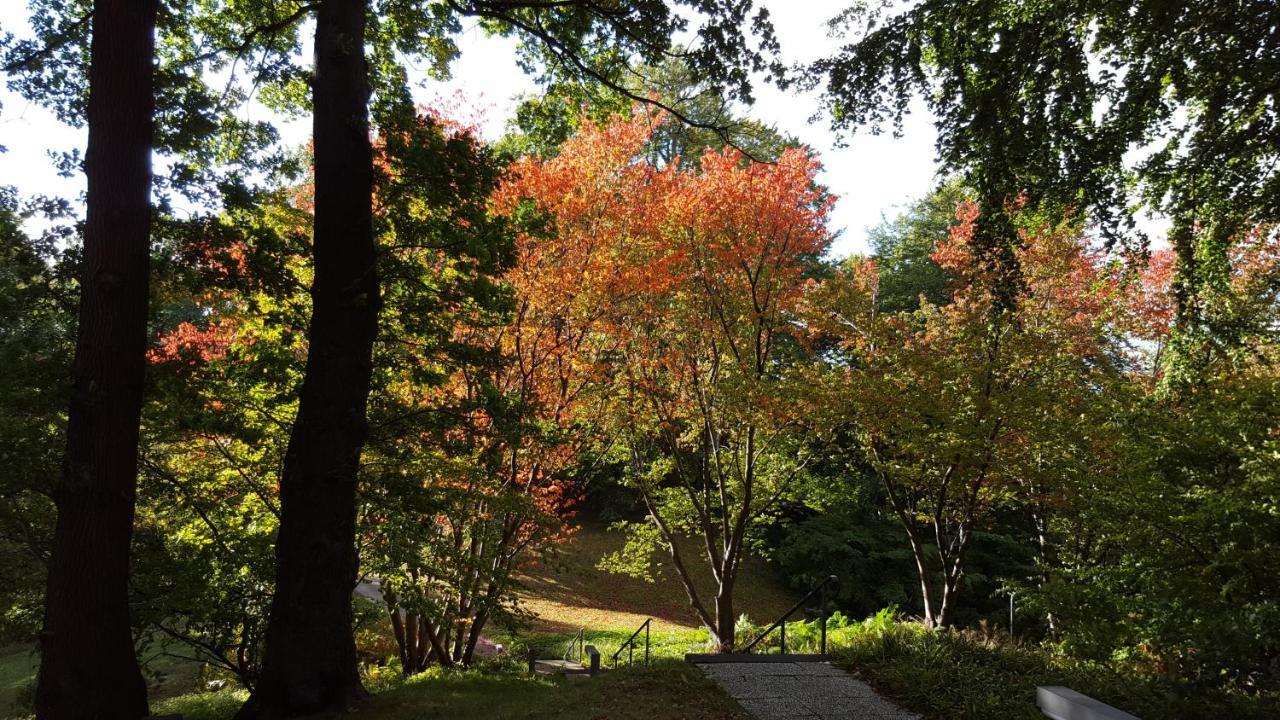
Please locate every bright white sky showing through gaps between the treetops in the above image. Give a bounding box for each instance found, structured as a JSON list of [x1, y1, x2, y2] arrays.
[[0, 0, 936, 256]]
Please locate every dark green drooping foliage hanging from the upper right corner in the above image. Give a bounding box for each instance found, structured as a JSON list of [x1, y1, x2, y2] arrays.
[[808, 0, 1280, 348]]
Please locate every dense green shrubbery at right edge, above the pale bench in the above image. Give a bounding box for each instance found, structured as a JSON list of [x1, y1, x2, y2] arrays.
[[1033, 373, 1280, 688]]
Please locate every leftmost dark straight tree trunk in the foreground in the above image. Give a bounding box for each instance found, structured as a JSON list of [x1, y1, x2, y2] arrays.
[[36, 0, 156, 720]]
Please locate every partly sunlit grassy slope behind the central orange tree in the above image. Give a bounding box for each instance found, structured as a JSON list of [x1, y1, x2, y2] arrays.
[[520, 524, 795, 633]]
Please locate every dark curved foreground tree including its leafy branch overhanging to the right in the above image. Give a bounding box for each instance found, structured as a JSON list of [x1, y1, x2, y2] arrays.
[[222, 0, 771, 717]]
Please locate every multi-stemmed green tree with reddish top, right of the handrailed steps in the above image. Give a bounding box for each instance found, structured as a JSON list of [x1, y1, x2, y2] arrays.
[[805, 204, 1114, 626]]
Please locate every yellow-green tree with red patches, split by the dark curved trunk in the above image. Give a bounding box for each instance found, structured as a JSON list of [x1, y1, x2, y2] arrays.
[[134, 105, 511, 688]]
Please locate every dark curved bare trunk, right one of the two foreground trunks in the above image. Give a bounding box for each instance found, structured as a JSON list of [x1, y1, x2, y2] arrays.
[[239, 0, 380, 719]]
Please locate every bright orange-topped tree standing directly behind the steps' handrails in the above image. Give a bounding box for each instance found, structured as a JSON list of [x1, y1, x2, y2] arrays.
[[517, 114, 831, 650]]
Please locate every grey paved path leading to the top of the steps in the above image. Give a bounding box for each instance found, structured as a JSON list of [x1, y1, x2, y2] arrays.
[[699, 662, 920, 720]]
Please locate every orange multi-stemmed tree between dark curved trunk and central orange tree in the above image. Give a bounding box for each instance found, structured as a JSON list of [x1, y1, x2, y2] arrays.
[[370, 107, 616, 674]]
